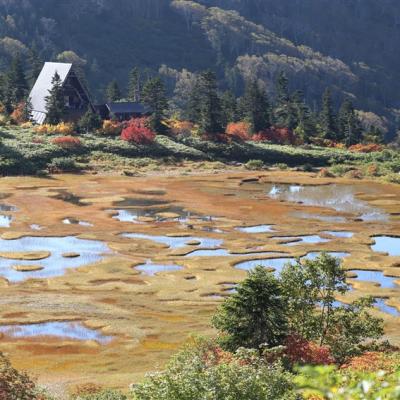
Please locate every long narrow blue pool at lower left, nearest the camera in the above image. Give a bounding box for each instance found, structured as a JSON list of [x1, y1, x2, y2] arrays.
[[0, 322, 113, 344]]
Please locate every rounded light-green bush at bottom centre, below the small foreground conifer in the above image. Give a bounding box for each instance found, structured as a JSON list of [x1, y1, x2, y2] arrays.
[[133, 341, 298, 400]]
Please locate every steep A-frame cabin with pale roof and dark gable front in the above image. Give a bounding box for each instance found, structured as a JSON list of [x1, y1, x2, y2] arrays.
[[30, 62, 94, 124]]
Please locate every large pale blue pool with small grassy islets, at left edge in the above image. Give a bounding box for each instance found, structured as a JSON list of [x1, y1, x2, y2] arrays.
[[0, 236, 110, 282]]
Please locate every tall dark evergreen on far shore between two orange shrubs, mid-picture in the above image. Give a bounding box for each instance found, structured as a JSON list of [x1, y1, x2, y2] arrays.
[[189, 71, 225, 136]]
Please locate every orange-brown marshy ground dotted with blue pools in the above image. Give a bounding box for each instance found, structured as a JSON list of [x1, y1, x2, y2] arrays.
[[0, 171, 400, 387]]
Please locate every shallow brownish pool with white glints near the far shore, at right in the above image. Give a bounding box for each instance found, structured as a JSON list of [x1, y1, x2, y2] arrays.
[[263, 183, 388, 221]]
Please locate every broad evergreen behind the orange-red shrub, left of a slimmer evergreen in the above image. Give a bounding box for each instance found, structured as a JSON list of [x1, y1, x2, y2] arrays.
[[241, 80, 271, 133]]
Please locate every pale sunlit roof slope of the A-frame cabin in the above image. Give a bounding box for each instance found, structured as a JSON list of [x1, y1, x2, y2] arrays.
[[30, 62, 72, 124]]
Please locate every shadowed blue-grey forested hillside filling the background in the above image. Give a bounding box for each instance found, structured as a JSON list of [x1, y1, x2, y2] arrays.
[[0, 0, 400, 134]]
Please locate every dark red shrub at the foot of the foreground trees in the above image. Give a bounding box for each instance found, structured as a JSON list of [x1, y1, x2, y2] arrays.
[[285, 334, 334, 365]]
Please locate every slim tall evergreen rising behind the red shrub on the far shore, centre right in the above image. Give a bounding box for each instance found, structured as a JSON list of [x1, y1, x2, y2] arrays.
[[274, 72, 296, 129]]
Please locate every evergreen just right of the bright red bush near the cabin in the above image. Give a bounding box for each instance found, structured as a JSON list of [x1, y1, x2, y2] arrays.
[[142, 77, 168, 134]]
